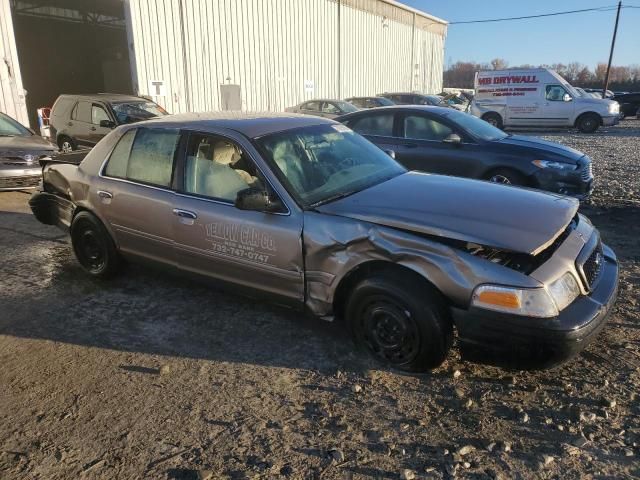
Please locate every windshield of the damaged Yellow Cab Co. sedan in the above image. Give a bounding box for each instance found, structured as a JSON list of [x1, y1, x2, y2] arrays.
[[257, 125, 406, 207]]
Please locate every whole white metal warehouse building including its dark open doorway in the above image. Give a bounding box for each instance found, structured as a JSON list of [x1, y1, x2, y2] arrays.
[[0, 0, 447, 127]]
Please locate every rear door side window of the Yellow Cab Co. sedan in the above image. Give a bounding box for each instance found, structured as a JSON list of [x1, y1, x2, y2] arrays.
[[105, 128, 180, 187]]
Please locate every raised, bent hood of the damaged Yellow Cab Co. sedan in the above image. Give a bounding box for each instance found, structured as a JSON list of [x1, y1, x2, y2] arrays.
[[317, 172, 579, 255]]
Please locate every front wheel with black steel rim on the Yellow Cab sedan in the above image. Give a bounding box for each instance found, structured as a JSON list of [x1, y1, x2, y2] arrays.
[[346, 273, 453, 372]]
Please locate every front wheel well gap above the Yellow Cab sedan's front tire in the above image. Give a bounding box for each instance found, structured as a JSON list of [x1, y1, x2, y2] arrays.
[[333, 260, 446, 319]]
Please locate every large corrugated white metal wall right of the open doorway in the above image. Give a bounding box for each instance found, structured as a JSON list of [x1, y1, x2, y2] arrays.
[[127, 0, 446, 113]]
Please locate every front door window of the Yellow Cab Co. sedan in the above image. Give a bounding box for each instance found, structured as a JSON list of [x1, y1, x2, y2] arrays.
[[184, 133, 264, 203]]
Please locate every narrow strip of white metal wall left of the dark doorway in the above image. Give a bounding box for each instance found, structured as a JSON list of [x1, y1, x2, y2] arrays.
[[0, 0, 29, 126]]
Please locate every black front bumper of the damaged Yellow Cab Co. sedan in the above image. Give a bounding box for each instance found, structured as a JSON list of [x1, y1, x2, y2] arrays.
[[452, 246, 618, 368]]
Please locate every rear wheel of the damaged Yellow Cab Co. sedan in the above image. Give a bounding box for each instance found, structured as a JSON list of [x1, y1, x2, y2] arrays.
[[71, 211, 121, 279]]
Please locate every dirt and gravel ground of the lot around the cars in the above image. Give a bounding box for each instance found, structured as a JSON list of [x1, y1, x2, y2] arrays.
[[0, 120, 640, 480]]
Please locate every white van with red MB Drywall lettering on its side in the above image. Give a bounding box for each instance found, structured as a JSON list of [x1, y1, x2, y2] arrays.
[[470, 68, 620, 133]]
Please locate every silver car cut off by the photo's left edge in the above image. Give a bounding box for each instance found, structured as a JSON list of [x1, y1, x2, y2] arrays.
[[0, 112, 57, 191]]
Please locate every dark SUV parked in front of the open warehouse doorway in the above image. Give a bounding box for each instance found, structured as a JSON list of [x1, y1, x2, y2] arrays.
[[49, 93, 167, 152]]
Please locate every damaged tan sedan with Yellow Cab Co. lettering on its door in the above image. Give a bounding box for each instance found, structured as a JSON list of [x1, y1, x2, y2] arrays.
[[30, 114, 618, 371]]
